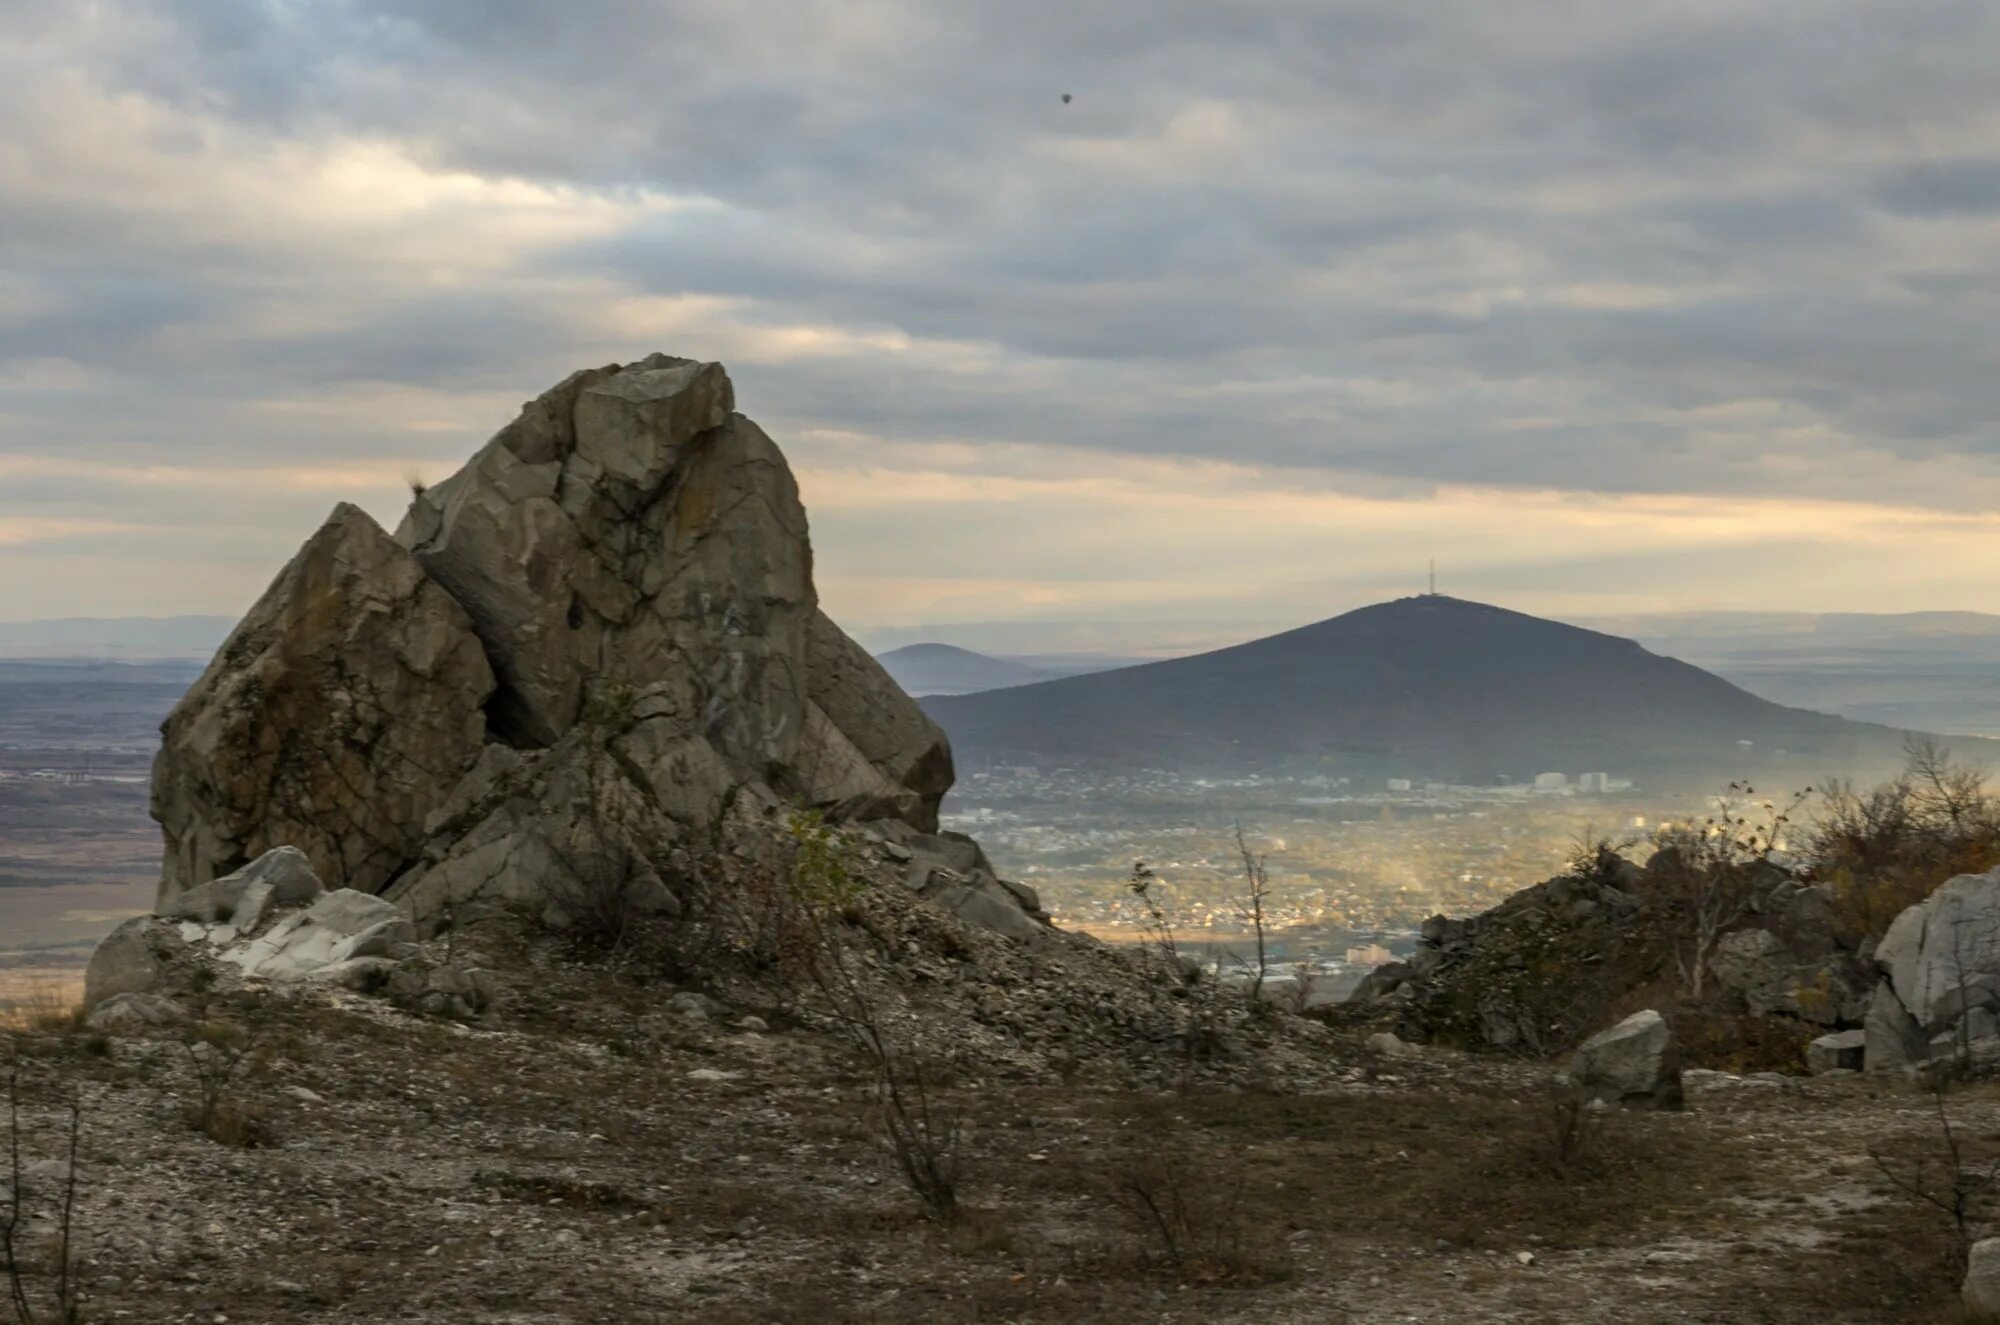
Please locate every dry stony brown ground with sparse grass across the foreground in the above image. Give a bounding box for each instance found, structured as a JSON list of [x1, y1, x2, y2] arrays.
[[0, 973, 2000, 1325]]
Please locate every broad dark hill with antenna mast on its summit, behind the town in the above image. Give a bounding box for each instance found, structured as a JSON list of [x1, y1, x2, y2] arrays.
[[924, 594, 1984, 785]]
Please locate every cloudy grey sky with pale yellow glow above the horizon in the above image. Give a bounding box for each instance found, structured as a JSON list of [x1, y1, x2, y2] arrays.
[[0, 0, 2000, 638]]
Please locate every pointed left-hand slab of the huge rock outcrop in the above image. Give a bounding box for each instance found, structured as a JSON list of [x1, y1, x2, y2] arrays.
[[152, 504, 494, 901]]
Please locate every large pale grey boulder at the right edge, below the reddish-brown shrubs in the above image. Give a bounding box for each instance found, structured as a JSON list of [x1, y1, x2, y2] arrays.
[[1866, 869, 2000, 1071]]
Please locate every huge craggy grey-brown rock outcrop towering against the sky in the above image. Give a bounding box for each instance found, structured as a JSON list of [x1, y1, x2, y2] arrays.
[[154, 354, 1016, 935]]
